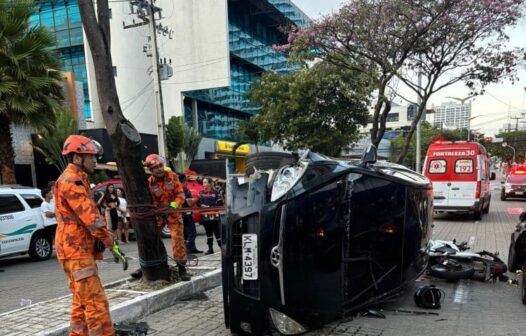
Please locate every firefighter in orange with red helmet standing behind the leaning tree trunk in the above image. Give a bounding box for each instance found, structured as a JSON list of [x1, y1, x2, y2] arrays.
[[145, 154, 190, 281]]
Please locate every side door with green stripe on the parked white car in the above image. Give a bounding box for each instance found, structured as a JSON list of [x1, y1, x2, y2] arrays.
[[0, 193, 29, 255]]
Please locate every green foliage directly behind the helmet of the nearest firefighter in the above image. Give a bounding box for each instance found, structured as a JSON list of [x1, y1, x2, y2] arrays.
[[33, 107, 79, 172]]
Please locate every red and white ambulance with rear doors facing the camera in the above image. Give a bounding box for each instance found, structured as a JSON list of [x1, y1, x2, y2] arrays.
[[423, 141, 495, 220]]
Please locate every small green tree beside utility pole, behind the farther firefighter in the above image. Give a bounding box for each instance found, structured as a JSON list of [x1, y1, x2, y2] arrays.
[[166, 117, 203, 172]]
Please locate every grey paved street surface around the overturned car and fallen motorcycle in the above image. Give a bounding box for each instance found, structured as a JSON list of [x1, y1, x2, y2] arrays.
[[145, 183, 526, 336]]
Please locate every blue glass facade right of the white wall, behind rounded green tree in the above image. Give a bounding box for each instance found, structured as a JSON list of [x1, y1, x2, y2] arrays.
[[184, 0, 307, 141]]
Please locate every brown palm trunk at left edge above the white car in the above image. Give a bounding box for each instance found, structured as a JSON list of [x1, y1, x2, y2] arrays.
[[0, 113, 16, 184]]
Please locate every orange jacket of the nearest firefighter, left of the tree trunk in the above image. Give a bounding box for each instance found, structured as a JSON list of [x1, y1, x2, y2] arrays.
[[55, 163, 113, 259]]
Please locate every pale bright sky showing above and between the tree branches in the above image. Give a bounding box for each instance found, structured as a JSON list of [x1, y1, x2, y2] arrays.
[[292, 0, 526, 135]]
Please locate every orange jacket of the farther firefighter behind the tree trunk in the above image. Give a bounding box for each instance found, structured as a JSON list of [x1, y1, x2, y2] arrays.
[[148, 171, 185, 217]]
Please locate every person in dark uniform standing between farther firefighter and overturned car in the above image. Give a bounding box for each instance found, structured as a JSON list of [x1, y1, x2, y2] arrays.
[[197, 177, 223, 255]]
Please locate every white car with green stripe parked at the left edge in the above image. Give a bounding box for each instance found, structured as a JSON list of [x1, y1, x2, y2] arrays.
[[0, 185, 53, 260]]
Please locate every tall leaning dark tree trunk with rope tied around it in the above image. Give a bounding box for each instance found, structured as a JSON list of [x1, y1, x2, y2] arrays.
[[79, 0, 171, 281]]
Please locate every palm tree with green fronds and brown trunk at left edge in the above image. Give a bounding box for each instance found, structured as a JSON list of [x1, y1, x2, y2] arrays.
[[0, 0, 62, 183]]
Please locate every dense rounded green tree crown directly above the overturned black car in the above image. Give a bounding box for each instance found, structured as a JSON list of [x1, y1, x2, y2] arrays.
[[249, 62, 371, 156]]
